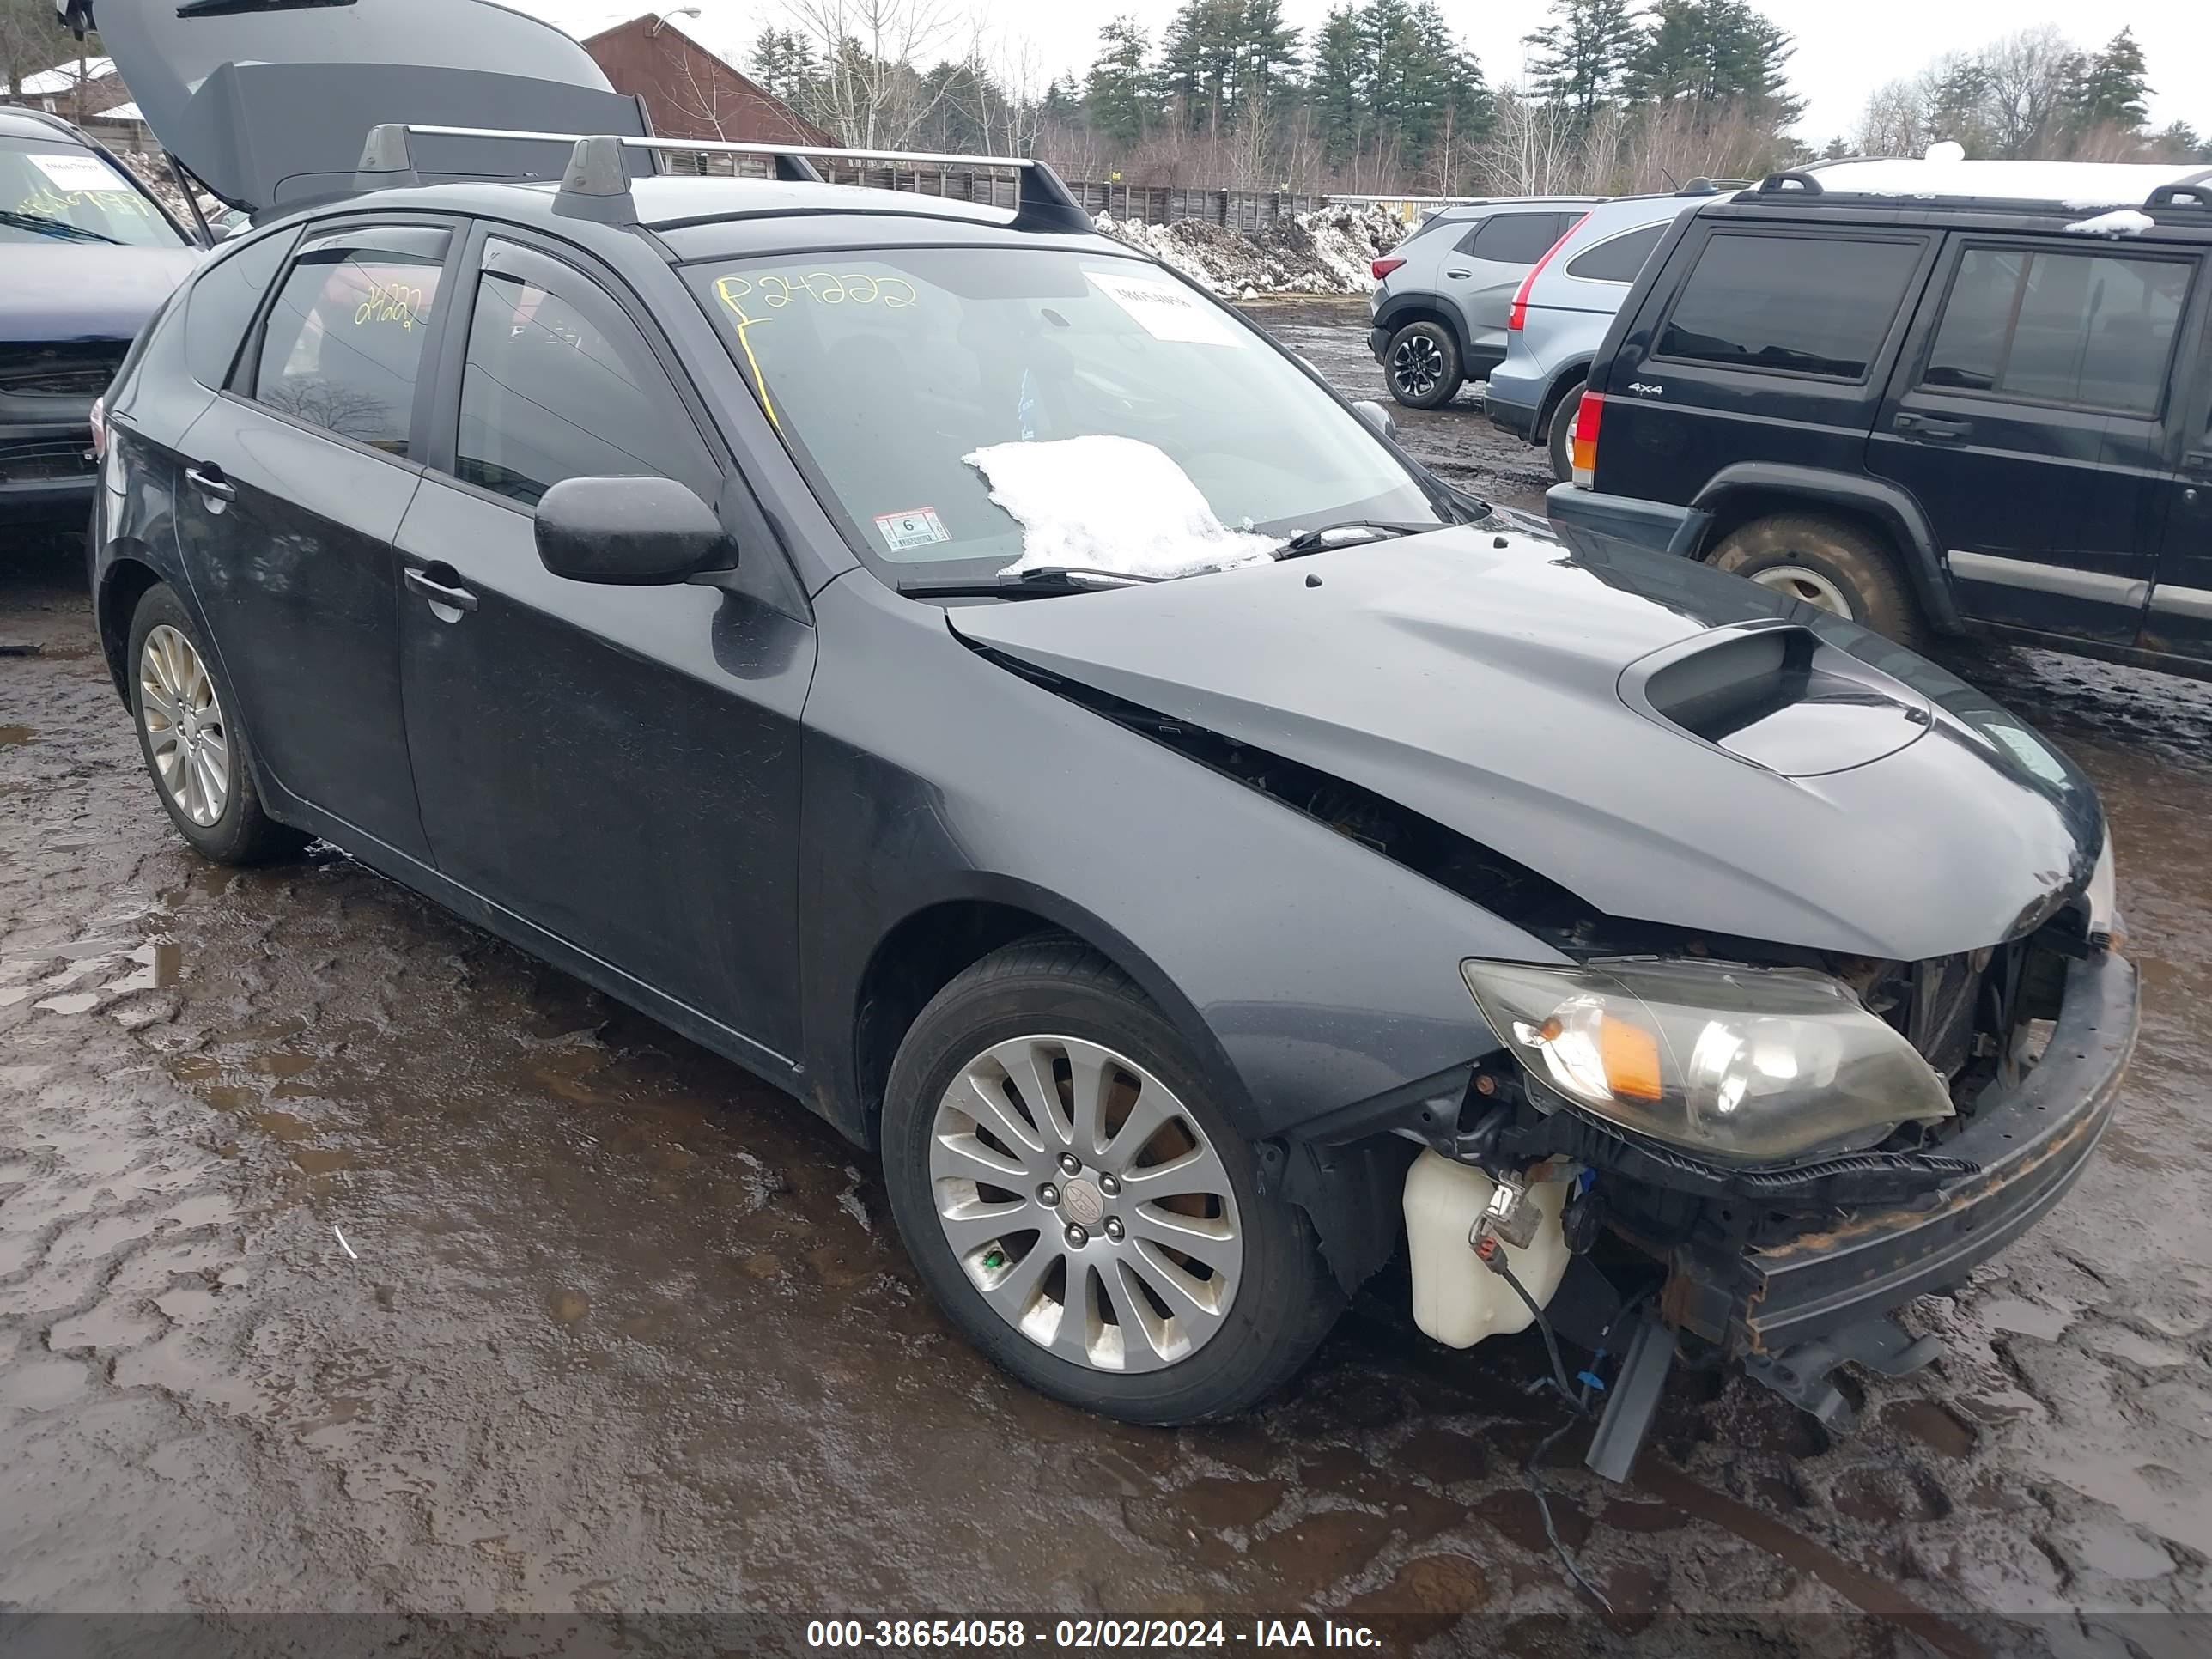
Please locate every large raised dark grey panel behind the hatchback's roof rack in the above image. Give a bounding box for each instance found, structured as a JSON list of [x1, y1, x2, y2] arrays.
[[80, 0, 648, 212]]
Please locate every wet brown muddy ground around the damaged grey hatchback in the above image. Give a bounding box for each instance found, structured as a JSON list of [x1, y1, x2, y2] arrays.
[[0, 307, 2212, 1659]]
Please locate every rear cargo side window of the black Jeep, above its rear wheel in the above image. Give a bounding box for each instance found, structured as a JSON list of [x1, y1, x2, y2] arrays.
[[1656, 234, 1924, 380]]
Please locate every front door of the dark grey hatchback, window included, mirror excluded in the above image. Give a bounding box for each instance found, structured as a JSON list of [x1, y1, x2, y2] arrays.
[[398, 237, 814, 1066]]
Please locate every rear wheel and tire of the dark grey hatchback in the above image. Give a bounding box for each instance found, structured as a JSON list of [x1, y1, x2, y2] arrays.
[[128, 581, 307, 865]]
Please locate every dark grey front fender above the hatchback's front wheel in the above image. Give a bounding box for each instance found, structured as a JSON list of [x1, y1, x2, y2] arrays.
[[801, 575, 1562, 1139]]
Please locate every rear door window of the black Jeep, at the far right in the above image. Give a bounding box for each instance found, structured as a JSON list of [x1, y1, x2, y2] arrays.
[[1920, 248, 2194, 416]]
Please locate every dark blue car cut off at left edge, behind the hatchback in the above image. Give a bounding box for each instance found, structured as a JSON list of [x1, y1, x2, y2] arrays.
[[0, 108, 201, 525]]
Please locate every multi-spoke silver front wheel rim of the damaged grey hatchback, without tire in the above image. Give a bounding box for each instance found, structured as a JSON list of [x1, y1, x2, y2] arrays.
[[929, 1036, 1243, 1371]]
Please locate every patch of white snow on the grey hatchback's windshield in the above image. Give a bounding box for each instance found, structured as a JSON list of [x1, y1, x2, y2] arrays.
[[963, 435, 1276, 575]]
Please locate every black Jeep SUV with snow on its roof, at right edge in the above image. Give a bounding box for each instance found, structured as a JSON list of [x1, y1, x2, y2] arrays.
[[1548, 161, 2212, 675]]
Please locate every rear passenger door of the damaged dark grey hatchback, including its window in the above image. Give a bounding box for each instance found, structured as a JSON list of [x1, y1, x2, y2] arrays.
[[177, 222, 456, 860]]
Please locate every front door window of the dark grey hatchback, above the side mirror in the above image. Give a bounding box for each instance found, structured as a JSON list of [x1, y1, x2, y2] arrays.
[[453, 241, 721, 507]]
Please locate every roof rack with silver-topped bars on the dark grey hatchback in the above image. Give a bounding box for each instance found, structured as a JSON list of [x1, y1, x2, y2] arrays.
[[354, 122, 1093, 234]]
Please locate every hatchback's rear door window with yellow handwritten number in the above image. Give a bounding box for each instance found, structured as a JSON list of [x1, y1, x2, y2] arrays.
[[252, 226, 449, 456]]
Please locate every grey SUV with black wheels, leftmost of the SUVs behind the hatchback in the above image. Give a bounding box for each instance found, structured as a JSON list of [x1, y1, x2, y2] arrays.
[[1367, 197, 1599, 410]]
